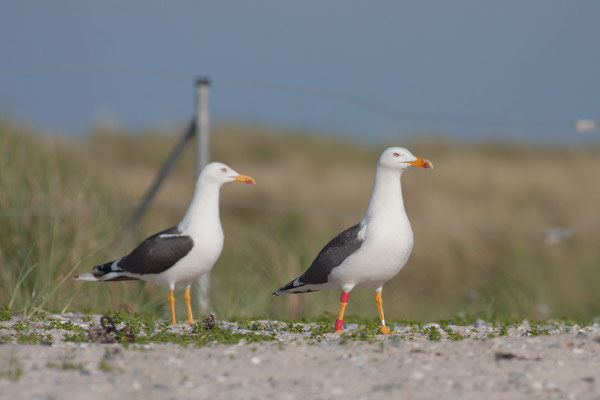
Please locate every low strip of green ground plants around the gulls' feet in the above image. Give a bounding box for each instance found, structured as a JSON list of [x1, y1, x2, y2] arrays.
[[0, 312, 586, 346]]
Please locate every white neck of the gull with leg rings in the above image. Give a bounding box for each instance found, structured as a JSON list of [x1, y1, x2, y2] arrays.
[[362, 166, 408, 225]]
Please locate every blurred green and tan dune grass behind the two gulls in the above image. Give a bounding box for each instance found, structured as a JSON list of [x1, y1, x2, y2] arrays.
[[0, 119, 600, 321]]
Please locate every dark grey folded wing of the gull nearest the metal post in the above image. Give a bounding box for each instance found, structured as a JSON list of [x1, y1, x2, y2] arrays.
[[117, 227, 194, 274]]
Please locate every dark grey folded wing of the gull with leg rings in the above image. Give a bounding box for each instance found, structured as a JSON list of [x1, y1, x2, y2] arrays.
[[299, 224, 363, 285]]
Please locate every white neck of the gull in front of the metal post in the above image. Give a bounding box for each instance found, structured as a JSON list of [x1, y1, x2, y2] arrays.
[[179, 176, 221, 231]]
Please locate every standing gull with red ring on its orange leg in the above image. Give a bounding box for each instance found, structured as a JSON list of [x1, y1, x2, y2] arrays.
[[273, 147, 433, 334]]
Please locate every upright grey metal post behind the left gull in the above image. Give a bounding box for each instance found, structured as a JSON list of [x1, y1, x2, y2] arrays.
[[196, 78, 210, 314]]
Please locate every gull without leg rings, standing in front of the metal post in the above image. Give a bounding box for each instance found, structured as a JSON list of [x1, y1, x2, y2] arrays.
[[74, 162, 254, 324]]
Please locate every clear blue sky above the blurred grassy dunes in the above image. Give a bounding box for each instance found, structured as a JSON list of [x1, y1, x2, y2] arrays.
[[0, 0, 600, 139]]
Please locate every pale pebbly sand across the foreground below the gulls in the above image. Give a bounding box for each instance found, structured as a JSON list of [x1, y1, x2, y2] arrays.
[[0, 316, 600, 400]]
